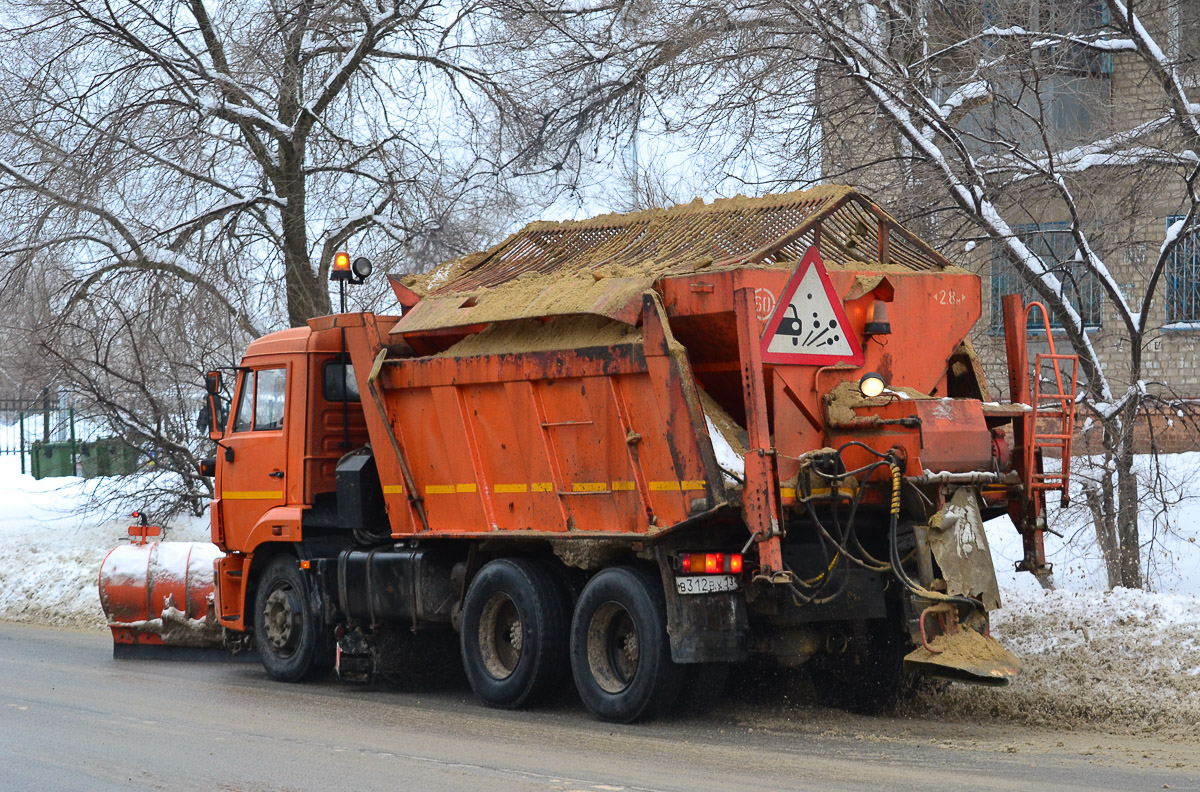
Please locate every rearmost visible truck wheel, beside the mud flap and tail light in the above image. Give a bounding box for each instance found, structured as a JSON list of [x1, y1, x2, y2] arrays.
[[571, 566, 683, 724]]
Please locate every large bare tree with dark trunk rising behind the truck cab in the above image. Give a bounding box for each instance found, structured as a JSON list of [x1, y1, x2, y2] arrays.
[[0, 0, 535, 510]]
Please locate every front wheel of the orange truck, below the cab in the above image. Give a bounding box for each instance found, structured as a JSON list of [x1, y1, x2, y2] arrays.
[[254, 556, 322, 682]]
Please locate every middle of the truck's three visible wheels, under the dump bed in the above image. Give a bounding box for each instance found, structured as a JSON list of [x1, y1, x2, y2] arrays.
[[462, 558, 569, 709]]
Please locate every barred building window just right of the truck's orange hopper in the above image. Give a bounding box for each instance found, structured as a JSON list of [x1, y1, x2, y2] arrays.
[[991, 223, 1104, 332]]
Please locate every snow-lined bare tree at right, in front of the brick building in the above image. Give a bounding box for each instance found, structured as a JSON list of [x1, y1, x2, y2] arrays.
[[489, 0, 1200, 587]]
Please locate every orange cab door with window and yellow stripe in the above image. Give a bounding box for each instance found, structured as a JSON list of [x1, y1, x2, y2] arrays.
[[218, 362, 291, 550]]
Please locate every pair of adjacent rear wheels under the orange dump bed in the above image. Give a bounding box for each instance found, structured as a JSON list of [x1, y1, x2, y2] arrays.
[[461, 558, 700, 724]]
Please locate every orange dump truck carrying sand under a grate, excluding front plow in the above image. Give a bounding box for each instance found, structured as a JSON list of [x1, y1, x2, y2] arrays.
[[108, 187, 1074, 721]]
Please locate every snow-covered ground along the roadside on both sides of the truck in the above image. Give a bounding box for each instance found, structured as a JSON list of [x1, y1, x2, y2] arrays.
[[0, 446, 1200, 730]]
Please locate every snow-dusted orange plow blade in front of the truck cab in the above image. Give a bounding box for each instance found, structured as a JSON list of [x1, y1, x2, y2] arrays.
[[100, 535, 223, 658]]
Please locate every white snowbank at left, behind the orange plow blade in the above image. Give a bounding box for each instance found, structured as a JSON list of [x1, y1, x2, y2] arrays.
[[0, 456, 209, 628]]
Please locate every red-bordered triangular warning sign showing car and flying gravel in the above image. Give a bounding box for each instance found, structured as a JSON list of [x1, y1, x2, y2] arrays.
[[762, 247, 863, 366]]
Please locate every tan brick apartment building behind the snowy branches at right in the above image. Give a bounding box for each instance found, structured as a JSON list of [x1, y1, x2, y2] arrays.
[[817, 0, 1200, 445]]
